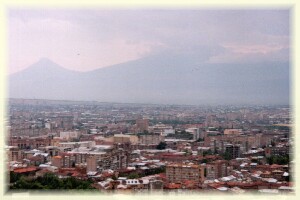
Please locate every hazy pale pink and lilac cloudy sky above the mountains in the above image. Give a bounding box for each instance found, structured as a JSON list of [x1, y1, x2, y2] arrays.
[[8, 9, 290, 73]]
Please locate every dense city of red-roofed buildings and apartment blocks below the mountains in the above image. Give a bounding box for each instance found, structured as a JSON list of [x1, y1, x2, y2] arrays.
[[6, 99, 294, 194]]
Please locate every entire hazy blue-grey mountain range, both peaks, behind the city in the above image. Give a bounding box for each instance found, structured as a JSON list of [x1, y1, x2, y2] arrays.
[[9, 54, 290, 104]]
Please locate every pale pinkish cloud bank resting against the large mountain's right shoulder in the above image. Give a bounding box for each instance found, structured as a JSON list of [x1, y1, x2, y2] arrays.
[[207, 32, 290, 63]]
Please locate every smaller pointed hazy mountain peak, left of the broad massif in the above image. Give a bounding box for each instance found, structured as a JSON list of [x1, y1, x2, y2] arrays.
[[9, 59, 81, 99]]
